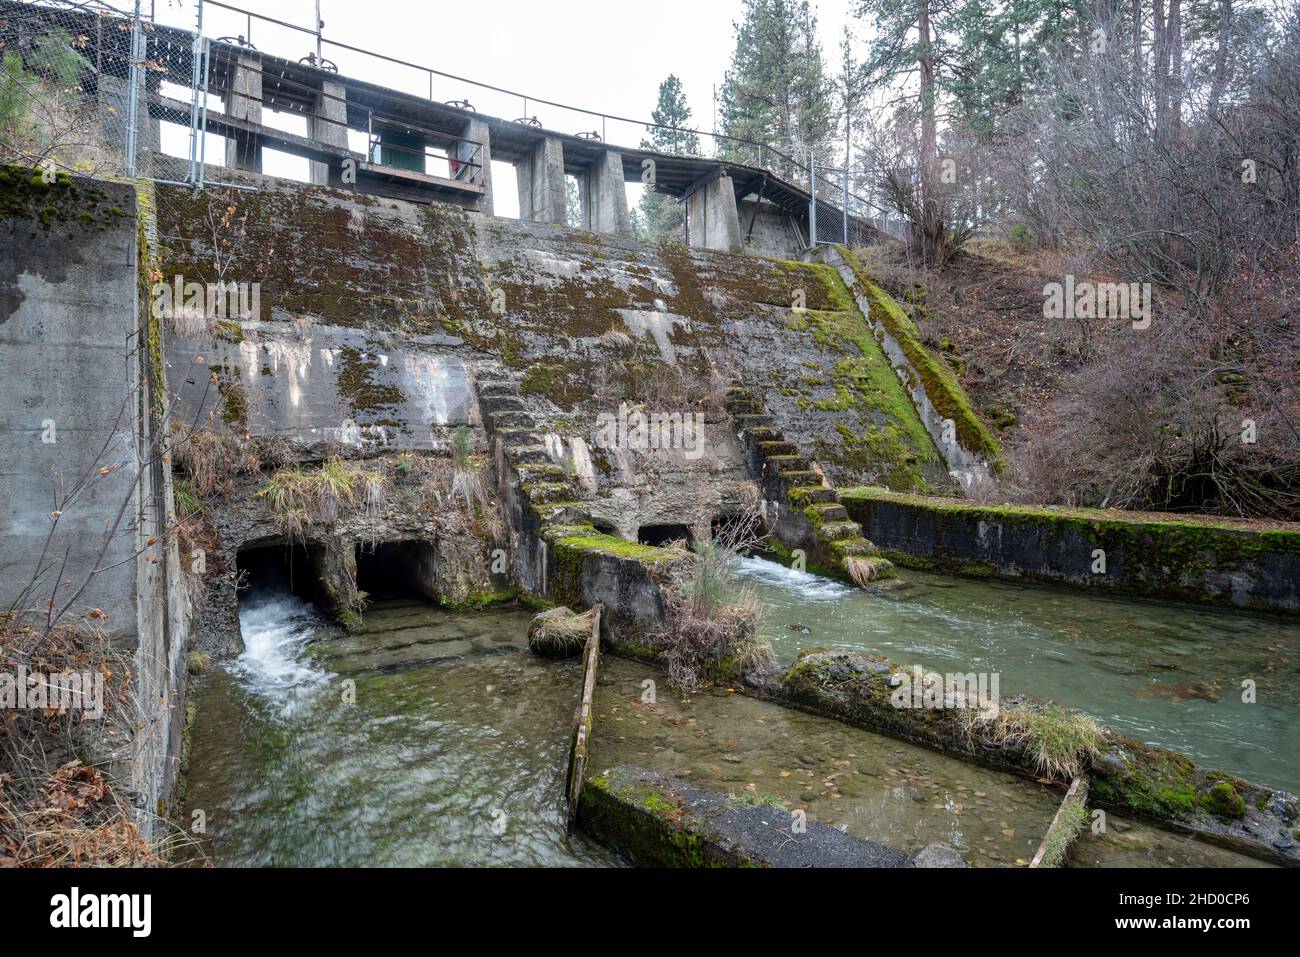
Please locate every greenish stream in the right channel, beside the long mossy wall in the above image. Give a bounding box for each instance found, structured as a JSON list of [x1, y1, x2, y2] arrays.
[[740, 558, 1300, 793]]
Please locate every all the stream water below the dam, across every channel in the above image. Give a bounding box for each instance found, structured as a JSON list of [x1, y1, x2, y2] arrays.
[[186, 559, 1300, 867]]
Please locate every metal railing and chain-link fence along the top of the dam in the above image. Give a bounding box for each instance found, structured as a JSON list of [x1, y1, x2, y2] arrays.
[[0, 0, 904, 242]]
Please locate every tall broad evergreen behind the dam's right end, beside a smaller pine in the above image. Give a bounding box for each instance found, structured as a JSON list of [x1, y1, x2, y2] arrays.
[[722, 0, 836, 172]]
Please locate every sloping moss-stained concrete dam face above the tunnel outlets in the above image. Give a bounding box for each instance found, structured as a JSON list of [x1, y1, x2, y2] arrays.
[[152, 178, 945, 538]]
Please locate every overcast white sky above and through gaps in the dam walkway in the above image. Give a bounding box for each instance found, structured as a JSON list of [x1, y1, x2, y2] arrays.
[[147, 0, 862, 215]]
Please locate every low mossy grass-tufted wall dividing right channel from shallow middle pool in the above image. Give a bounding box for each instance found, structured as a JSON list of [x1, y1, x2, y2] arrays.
[[757, 649, 1300, 866]]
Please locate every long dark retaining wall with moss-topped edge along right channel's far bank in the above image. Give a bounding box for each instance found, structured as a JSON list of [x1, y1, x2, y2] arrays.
[[841, 489, 1300, 611]]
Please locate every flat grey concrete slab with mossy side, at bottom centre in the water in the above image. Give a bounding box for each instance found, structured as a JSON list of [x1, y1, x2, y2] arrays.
[[579, 766, 911, 867]]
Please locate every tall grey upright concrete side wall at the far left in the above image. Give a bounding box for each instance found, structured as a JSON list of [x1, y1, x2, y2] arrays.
[[0, 170, 189, 833]]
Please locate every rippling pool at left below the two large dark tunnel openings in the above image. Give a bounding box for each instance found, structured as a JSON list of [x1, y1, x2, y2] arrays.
[[187, 594, 621, 867]]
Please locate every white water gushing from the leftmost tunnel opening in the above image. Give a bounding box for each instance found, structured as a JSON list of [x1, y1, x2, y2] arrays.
[[231, 594, 330, 718]]
